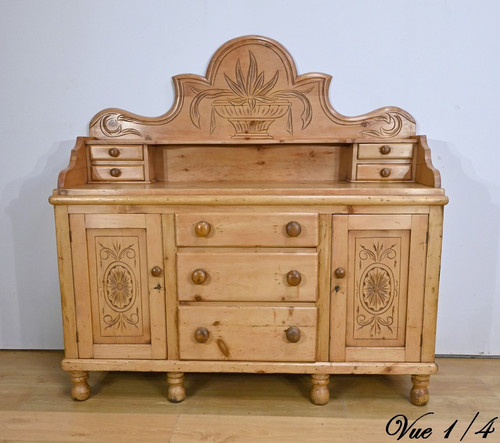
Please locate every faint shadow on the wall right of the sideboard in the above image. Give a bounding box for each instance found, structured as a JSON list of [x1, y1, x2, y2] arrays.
[[429, 140, 500, 355]]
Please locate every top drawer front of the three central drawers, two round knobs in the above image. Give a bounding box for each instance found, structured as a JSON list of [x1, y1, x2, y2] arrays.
[[176, 213, 318, 247]]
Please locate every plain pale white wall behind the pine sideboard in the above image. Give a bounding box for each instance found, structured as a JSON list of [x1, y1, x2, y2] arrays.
[[0, 0, 500, 355]]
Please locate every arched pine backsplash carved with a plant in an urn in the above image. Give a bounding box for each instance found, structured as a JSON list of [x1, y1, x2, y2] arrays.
[[89, 36, 415, 143]]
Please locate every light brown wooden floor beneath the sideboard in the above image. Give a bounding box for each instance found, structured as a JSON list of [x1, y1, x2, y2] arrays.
[[0, 351, 500, 443]]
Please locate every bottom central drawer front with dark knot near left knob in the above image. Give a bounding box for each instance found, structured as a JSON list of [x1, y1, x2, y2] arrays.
[[179, 306, 317, 361]]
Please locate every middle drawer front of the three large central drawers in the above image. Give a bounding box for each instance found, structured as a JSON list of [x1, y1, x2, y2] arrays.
[[177, 248, 318, 302]]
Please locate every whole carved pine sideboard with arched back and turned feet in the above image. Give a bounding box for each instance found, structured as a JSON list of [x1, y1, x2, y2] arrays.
[[50, 36, 448, 405]]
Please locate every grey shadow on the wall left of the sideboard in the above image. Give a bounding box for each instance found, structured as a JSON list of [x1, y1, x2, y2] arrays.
[[0, 141, 74, 349]]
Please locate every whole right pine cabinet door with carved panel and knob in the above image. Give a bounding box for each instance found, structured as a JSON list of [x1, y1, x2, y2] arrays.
[[330, 214, 428, 362]]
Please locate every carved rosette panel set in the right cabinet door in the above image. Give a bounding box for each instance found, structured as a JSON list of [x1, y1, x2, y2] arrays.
[[353, 238, 402, 339]]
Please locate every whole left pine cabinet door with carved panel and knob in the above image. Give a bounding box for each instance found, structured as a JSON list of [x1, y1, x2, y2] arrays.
[[70, 214, 167, 359]]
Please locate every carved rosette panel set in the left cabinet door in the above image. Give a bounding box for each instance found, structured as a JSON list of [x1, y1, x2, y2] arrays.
[[95, 237, 143, 337]]
